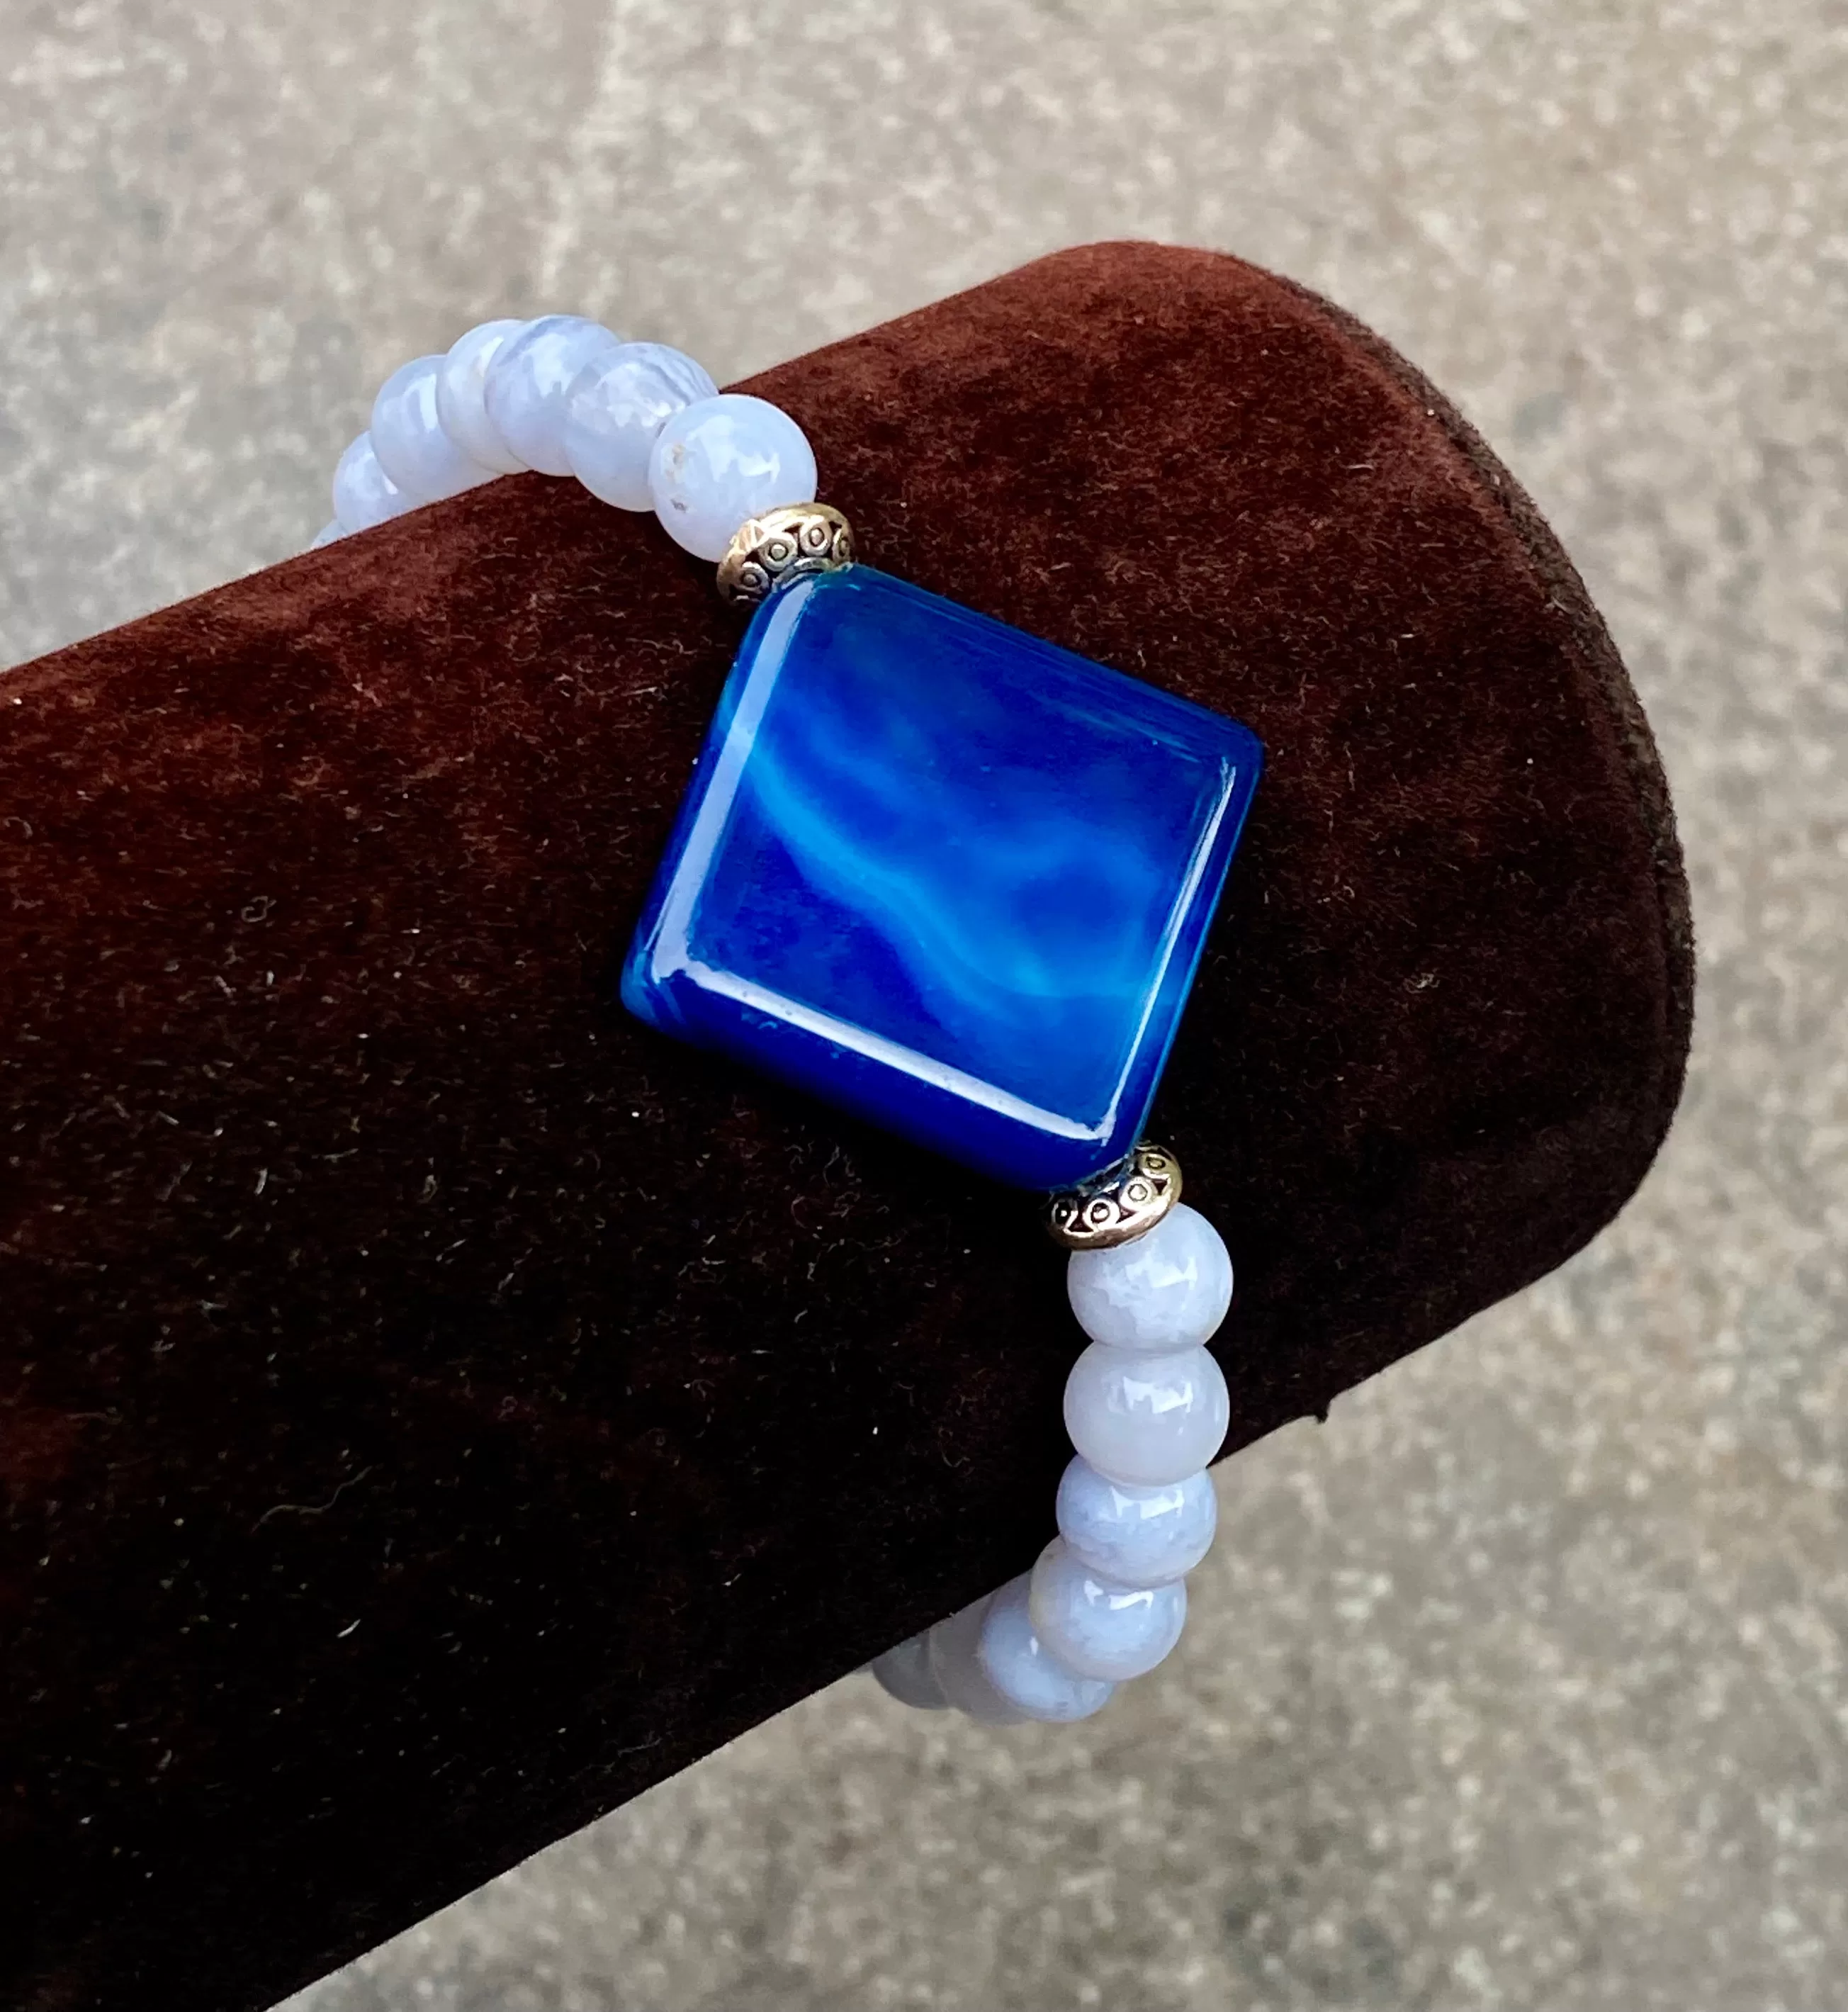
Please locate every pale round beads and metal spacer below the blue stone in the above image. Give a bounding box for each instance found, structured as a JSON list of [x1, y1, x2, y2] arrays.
[[871, 1145, 1233, 1724]]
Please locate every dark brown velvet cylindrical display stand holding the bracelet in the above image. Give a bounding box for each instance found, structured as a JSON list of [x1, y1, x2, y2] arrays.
[[0, 245, 1691, 2012]]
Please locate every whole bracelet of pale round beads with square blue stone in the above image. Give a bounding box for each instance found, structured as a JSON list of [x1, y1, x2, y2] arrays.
[[314, 314, 1263, 1724]]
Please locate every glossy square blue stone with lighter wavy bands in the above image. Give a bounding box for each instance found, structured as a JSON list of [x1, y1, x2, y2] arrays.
[[621, 566, 1261, 1189]]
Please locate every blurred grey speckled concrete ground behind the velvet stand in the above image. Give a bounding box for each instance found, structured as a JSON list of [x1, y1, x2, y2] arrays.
[[0, 0, 1848, 2012]]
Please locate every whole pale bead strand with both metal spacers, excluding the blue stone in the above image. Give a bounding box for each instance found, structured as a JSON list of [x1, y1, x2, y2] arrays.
[[314, 314, 1233, 1724]]
